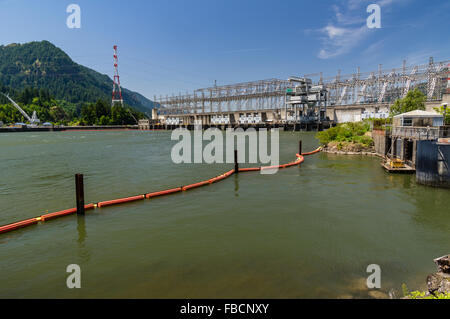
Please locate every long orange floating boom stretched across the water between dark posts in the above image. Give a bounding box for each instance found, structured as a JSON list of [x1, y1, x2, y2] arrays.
[[0, 147, 322, 234]]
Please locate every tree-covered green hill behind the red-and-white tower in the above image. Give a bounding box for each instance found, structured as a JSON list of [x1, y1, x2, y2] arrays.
[[0, 41, 153, 112]]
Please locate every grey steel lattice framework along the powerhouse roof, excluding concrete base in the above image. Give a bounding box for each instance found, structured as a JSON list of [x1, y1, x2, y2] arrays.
[[154, 58, 450, 115]]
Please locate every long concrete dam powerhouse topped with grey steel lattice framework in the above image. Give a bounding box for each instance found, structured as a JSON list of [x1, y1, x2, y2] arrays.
[[154, 58, 450, 125]]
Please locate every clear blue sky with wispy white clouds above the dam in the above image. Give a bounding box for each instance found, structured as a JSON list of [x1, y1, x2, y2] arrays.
[[0, 0, 450, 98]]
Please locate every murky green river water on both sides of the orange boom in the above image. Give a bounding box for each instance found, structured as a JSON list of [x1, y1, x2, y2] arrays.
[[0, 131, 450, 298]]
